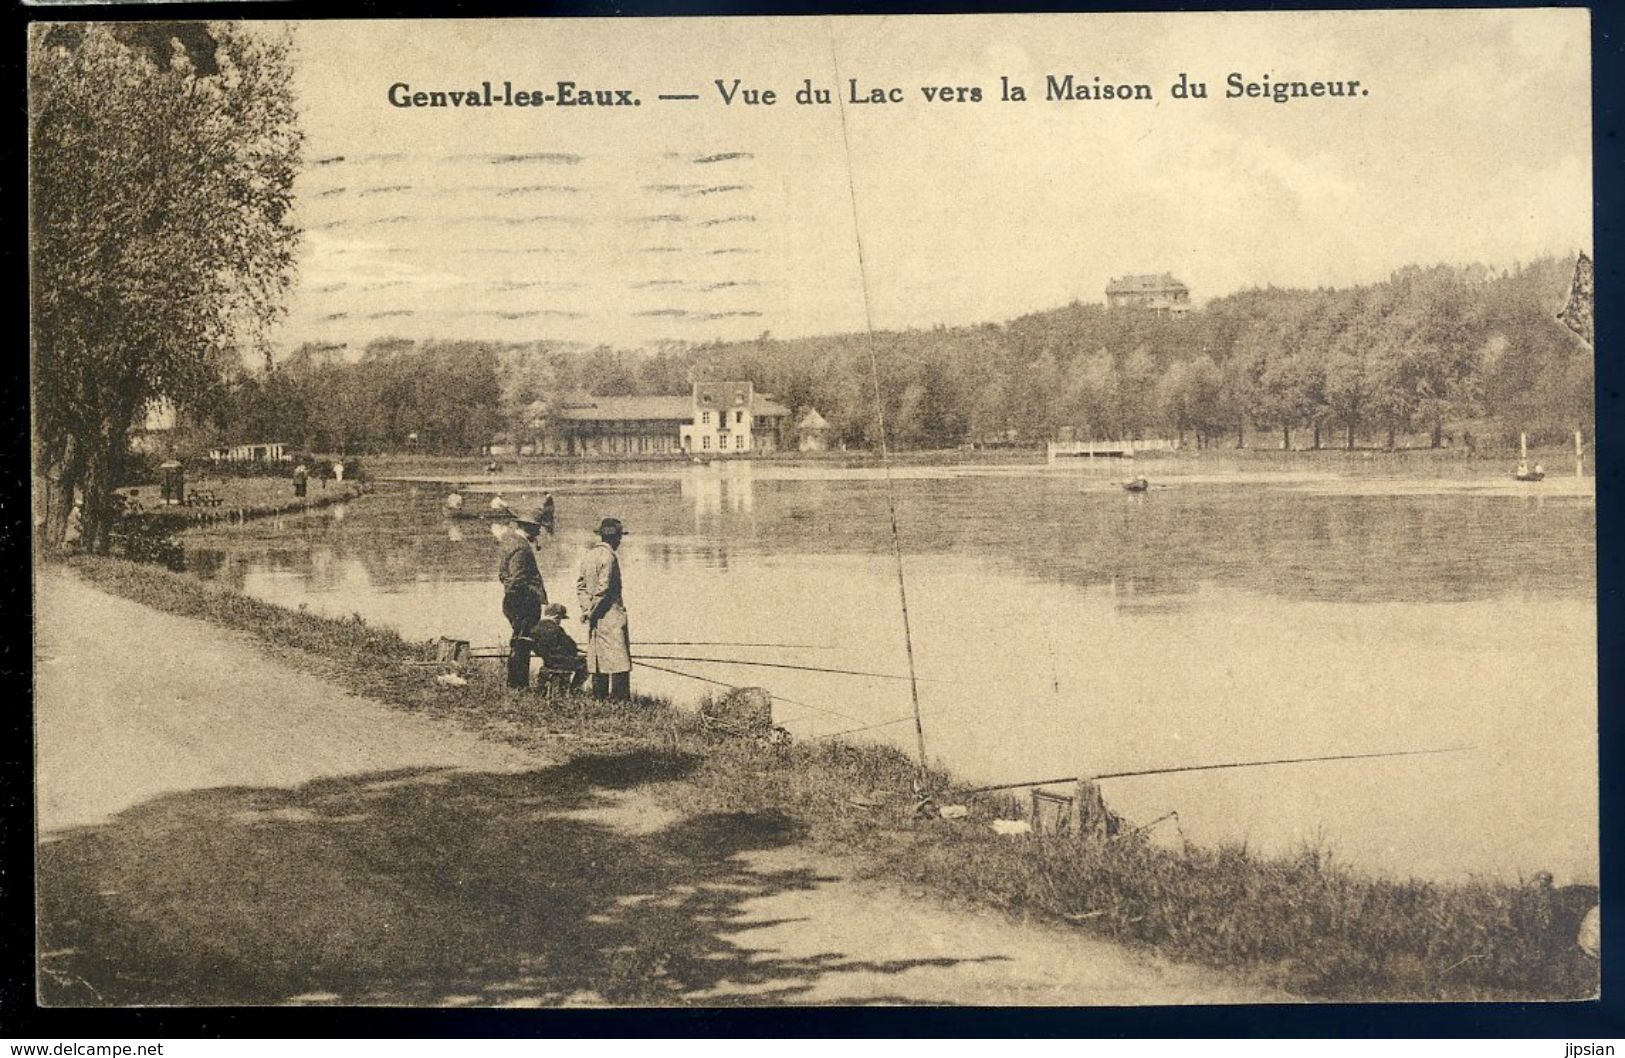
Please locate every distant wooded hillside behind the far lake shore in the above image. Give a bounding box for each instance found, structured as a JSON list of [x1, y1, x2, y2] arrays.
[[198, 257, 1593, 452]]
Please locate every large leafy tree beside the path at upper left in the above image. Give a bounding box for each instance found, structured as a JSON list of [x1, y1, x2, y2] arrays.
[[28, 23, 301, 548]]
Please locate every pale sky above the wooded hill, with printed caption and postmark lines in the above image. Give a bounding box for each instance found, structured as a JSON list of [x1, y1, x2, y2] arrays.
[[275, 10, 1591, 349]]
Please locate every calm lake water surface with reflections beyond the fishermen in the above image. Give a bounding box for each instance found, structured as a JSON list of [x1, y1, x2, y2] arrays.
[[189, 465, 1596, 878]]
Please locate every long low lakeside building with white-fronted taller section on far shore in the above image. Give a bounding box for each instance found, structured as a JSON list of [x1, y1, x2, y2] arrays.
[[538, 382, 790, 457]]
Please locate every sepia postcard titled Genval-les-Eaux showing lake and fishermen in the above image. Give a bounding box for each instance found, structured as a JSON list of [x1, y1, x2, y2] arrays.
[[28, 8, 1601, 1008]]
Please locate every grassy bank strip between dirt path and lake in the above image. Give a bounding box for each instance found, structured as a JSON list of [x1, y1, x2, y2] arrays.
[[70, 556, 1601, 1001]]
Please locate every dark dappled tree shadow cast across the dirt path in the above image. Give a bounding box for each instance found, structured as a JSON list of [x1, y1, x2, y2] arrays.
[[37, 752, 994, 1006]]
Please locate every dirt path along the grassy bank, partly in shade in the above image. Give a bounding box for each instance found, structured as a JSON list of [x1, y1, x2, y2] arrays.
[[36, 569, 1282, 1006]]
